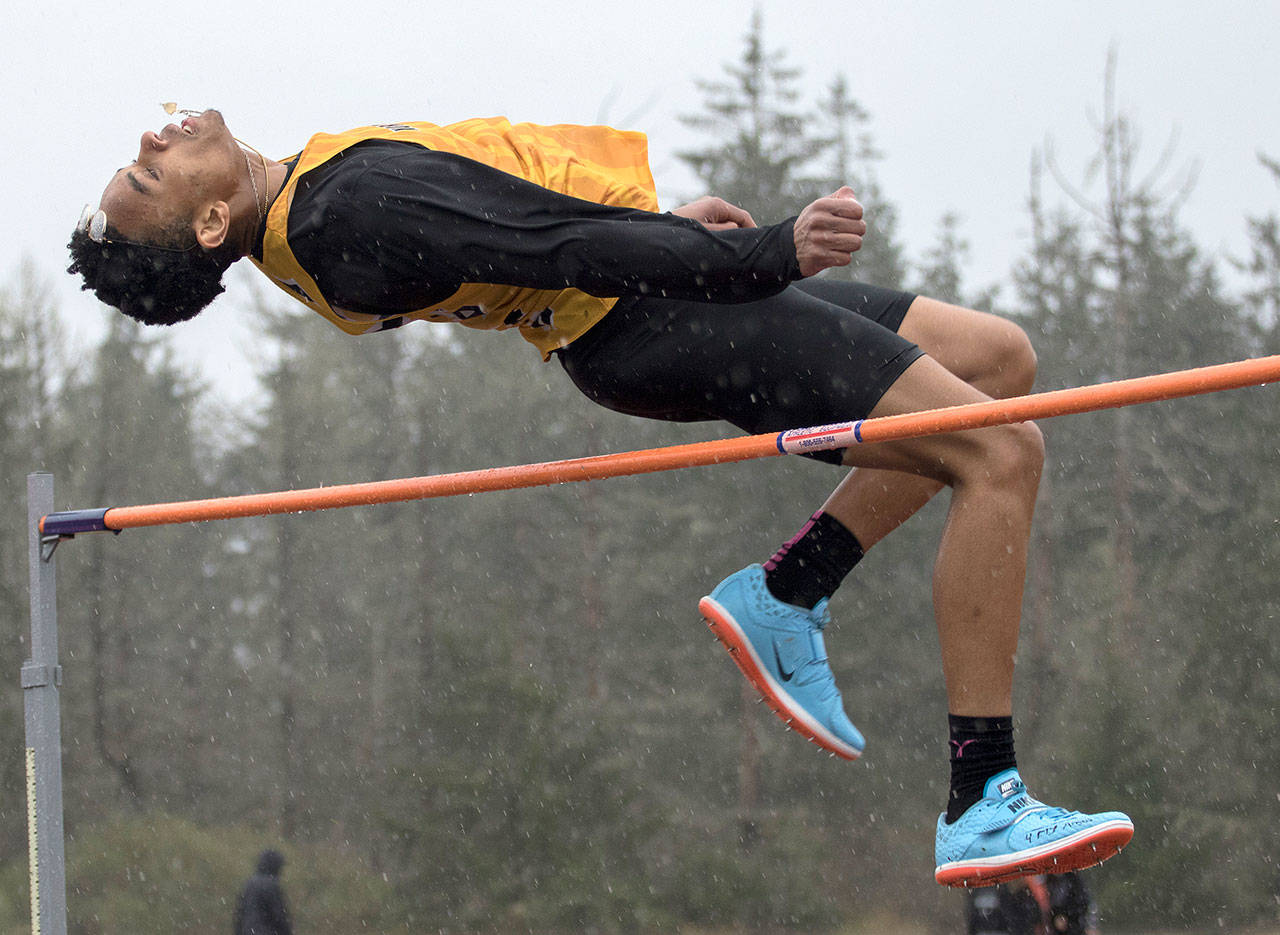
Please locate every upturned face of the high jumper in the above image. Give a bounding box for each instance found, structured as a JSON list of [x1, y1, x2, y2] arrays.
[[100, 110, 247, 242]]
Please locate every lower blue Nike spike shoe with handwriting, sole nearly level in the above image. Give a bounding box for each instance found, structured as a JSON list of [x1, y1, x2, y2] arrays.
[[933, 770, 1133, 886]]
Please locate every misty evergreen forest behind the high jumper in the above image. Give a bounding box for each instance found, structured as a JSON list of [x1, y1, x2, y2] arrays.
[[0, 22, 1280, 935]]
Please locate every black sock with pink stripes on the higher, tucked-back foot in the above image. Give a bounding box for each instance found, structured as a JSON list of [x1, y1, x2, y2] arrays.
[[764, 510, 863, 608]]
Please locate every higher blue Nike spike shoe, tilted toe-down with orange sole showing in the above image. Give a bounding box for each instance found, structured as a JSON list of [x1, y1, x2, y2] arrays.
[[698, 565, 867, 760]]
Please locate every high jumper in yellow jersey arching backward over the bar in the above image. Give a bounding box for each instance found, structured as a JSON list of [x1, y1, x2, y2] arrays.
[[69, 110, 1133, 886]]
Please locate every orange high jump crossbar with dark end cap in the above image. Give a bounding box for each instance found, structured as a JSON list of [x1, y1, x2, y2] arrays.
[[40, 355, 1280, 537]]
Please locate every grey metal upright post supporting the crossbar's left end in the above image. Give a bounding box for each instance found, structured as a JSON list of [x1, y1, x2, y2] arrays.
[[22, 474, 67, 935]]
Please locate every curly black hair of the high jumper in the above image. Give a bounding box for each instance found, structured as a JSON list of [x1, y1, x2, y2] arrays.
[[67, 223, 239, 324]]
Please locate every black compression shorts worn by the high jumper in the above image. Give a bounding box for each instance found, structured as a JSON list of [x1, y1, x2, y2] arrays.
[[559, 279, 923, 464]]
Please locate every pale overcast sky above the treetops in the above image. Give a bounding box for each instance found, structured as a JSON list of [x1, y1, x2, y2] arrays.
[[0, 0, 1280, 393]]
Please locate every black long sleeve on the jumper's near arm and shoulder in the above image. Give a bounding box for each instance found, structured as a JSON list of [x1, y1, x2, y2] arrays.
[[280, 140, 799, 315]]
